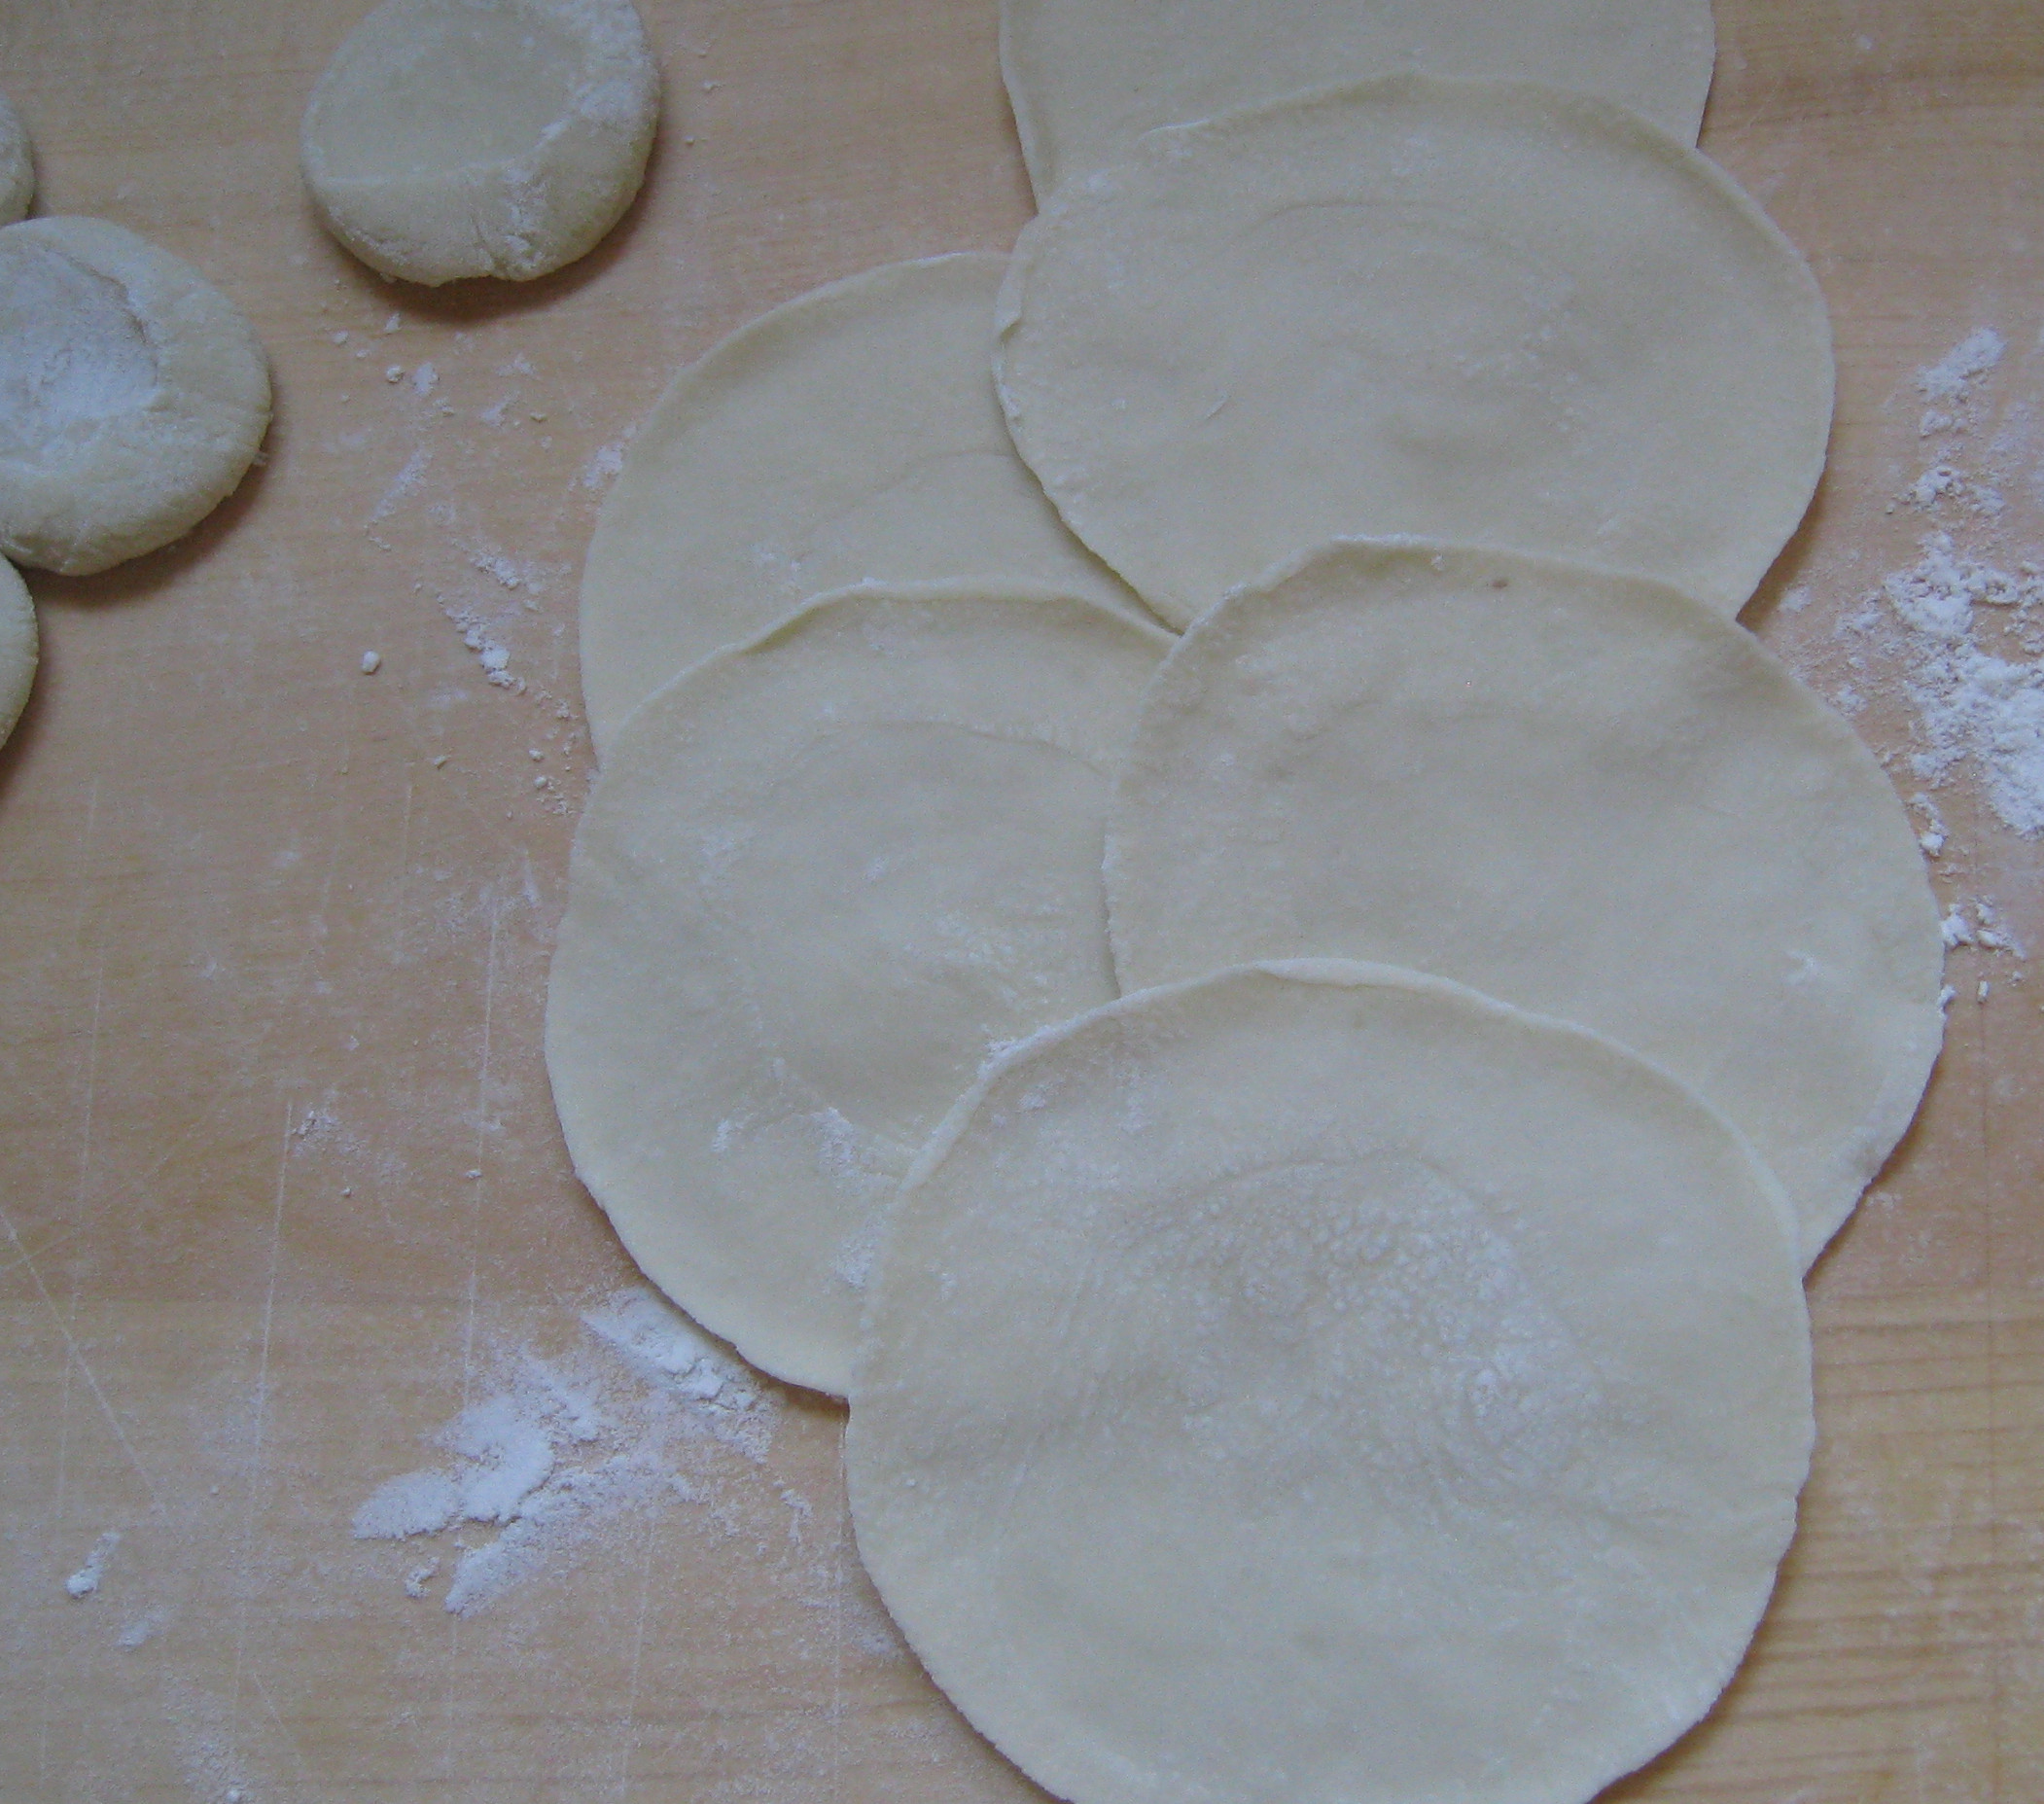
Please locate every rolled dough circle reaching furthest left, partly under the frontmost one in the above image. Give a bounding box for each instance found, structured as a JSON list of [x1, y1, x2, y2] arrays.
[[546, 585, 1171, 1393]]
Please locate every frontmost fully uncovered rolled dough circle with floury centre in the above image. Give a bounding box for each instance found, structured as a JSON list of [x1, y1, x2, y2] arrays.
[[846, 964, 1813, 1804]]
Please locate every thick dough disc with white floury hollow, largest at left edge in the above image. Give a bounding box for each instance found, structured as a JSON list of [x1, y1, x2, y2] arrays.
[[0, 219, 269, 575]]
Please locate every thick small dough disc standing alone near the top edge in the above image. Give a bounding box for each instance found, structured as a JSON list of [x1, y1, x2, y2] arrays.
[[300, 0, 660, 282]]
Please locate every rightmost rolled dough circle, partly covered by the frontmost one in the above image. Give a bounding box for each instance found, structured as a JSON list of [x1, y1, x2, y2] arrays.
[[1108, 547, 1944, 1262]]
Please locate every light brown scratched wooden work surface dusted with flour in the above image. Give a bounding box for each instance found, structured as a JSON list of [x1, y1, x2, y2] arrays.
[[0, 0, 2044, 1804]]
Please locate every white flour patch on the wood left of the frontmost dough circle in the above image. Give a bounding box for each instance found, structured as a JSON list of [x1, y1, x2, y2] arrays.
[[354, 1289, 780, 1616]]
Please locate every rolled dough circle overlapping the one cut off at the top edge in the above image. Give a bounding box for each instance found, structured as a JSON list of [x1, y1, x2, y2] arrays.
[[1000, 76, 1831, 626]]
